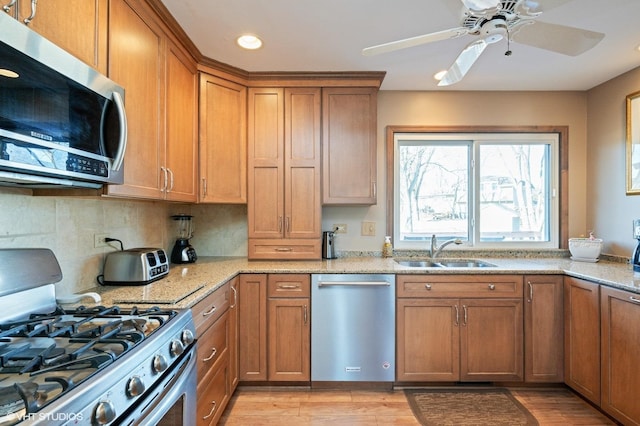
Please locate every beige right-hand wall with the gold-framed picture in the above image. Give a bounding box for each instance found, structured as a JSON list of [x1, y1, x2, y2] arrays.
[[585, 68, 640, 257]]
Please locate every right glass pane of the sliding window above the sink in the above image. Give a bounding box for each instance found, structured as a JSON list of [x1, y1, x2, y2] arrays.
[[477, 144, 549, 242]]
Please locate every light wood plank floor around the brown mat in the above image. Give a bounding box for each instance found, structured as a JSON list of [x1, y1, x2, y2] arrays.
[[219, 388, 615, 426]]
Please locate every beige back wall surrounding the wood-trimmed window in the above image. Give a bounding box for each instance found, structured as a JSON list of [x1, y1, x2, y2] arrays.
[[322, 91, 592, 251]]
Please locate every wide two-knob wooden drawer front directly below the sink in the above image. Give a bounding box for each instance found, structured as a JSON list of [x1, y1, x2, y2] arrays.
[[396, 275, 522, 298]]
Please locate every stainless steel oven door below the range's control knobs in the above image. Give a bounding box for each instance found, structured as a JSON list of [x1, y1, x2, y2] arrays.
[[114, 345, 197, 426]]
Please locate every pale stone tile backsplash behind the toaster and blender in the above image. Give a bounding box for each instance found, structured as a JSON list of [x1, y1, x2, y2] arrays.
[[0, 188, 247, 294]]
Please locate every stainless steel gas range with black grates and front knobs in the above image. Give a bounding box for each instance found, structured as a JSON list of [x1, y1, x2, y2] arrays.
[[0, 249, 196, 426]]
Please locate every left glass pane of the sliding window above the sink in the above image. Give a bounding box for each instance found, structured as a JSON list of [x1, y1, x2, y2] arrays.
[[398, 141, 469, 242]]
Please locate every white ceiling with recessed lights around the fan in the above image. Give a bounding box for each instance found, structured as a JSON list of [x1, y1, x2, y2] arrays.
[[162, 0, 640, 91]]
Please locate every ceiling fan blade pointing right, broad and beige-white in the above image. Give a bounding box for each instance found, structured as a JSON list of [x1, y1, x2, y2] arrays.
[[511, 21, 604, 56]]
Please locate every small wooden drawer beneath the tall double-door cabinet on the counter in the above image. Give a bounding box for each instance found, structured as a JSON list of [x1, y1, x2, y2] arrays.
[[249, 237, 322, 260]]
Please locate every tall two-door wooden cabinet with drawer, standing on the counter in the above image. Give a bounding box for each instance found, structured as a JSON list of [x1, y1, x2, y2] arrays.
[[248, 88, 322, 259]]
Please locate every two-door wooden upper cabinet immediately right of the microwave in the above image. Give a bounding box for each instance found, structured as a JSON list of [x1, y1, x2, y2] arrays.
[[107, 0, 197, 201]]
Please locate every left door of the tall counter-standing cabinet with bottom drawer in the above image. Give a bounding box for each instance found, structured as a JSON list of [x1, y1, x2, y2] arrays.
[[248, 88, 284, 238]]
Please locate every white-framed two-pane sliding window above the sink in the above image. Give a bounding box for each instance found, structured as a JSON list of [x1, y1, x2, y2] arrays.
[[390, 131, 562, 250]]
